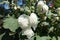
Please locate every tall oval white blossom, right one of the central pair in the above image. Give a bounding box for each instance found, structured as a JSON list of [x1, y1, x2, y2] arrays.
[[29, 13, 39, 30]]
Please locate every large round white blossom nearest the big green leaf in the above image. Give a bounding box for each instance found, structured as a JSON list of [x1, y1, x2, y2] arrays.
[[18, 14, 29, 29]]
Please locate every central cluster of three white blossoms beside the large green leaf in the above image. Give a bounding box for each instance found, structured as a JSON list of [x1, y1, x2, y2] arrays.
[[18, 13, 39, 38]]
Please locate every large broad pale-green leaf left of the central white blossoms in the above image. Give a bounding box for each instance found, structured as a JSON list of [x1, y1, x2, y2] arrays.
[[3, 17, 19, 32]]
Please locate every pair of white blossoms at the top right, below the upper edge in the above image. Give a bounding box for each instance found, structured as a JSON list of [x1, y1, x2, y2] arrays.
[[37, 1, 49, 15]]
